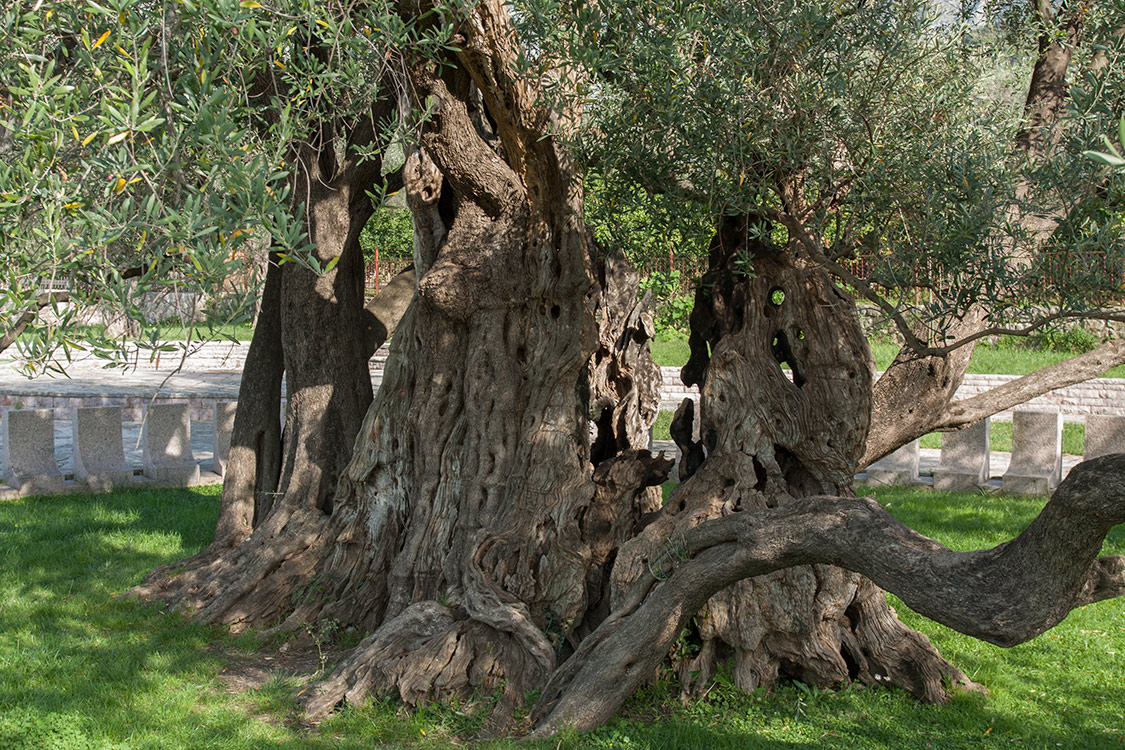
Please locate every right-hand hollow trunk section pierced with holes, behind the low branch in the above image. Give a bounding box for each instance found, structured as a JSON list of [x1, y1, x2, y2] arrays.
[[613, 219, 966, 701]]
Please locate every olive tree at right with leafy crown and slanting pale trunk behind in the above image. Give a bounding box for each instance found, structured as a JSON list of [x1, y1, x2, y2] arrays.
[[528, 2, 1125, 466]]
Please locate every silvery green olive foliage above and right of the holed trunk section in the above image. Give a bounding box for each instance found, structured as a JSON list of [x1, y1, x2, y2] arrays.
[[520, 0, 1125, 346]]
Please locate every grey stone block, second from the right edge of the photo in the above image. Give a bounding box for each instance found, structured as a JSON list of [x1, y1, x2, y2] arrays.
[[1001, 412, 1062, 496]]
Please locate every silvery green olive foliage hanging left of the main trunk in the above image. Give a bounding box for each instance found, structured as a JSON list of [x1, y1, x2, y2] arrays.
[[0, 0, 448, 370]]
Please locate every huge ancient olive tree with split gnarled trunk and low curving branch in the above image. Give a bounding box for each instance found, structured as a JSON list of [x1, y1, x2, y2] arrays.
[[19, 0, 1125, 732]]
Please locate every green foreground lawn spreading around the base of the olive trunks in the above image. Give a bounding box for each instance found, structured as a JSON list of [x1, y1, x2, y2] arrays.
[[0, 488, 1125, 750]]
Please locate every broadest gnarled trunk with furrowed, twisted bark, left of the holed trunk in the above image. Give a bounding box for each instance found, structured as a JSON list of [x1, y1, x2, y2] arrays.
[[138, 2, 671, 721]]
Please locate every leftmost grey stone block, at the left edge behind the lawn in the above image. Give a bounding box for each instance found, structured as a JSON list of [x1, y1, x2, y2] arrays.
[[2, 409, 66, 495]]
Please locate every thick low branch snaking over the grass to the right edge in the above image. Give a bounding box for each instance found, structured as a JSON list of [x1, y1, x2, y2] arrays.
[[532, 454, 1125, 735]]
